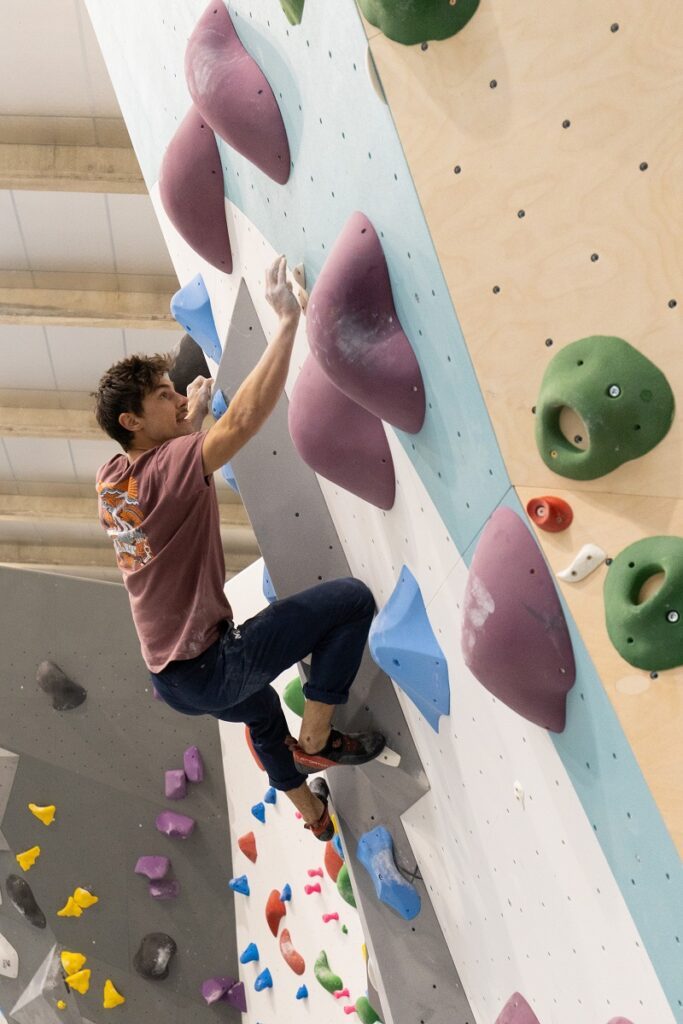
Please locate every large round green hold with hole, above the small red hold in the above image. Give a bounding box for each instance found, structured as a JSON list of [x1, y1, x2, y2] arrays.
[[536, 336, 674, 480]]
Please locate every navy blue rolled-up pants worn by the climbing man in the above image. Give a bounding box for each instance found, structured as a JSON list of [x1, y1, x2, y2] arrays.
[[151, 579, 375, 791]]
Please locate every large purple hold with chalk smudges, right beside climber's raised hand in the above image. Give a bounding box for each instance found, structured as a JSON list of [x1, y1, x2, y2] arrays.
[[306, 213, 425, 433]]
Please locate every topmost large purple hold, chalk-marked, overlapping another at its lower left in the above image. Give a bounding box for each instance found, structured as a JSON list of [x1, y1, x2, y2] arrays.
[[185, 0, 290, 184]]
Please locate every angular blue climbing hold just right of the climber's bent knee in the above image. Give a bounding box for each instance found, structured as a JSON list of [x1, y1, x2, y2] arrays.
[[370, 565, 451, 732]]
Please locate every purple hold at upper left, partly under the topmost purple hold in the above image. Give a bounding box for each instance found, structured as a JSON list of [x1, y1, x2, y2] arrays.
[[159, 106, 232, 273]]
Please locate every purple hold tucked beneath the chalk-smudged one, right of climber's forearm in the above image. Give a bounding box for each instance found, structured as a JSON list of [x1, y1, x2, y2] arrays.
[[289, 355, 396, 509]]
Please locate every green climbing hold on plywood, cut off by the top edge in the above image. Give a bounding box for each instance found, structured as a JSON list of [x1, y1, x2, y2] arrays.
[[358, 0, 479, 46]]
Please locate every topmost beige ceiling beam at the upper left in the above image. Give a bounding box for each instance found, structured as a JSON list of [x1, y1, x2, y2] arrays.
[[0, 142, 147, 195]]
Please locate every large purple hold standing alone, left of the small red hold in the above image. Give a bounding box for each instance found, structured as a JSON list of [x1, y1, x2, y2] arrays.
[[462, 508, 575, 732]]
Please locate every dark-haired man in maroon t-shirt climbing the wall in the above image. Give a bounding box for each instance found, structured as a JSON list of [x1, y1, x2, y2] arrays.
[[94, 257, 384, 841]]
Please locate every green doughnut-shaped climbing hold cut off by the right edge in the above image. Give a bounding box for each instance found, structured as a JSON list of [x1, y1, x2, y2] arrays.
[[604, 537, 683, 672]]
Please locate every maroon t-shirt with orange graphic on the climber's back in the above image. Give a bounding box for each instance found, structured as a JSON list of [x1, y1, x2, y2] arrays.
[[97, 432, 232, 673]]
